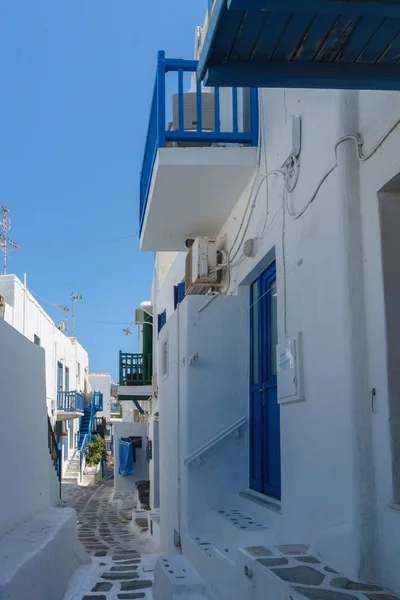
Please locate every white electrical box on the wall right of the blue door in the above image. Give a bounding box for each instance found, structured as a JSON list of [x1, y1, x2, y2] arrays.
[[276, 333, 304, 404]]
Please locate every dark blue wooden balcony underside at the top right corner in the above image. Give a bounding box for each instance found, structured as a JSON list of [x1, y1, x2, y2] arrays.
[[197, 0, 400, 90]]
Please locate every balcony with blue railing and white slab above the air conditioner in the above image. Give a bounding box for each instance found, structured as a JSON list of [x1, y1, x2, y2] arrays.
[[139, 52, 258, 252]]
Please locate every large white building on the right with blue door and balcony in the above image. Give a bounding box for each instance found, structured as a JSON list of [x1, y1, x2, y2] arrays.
[[140, 11, 400, 600]]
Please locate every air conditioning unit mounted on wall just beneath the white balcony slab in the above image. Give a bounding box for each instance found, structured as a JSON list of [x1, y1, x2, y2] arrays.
[[185, 237, 221, 294]]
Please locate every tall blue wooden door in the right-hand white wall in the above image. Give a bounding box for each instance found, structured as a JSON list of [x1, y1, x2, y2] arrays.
[[250, 263, 281, 498]]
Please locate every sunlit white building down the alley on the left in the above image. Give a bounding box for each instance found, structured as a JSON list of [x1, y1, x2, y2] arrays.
[[0, 275, 89, 462]]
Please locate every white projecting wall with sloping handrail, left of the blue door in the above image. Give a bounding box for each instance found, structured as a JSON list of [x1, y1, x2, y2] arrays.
[[158, 296, 248, 551]]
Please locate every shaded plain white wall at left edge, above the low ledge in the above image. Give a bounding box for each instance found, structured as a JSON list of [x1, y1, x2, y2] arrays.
[[0, 321, 57, 536]]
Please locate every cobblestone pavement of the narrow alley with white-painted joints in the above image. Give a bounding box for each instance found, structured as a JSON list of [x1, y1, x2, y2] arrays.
[[61, 477, 157, 600]]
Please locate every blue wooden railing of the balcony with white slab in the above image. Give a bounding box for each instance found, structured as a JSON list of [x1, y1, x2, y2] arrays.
[[139, 51, 258, 231]]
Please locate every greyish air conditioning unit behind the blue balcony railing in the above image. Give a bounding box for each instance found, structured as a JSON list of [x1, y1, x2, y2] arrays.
[[172, 92, 215, 131]]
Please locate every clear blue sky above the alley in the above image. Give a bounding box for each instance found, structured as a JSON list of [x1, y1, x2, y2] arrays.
[[0, 0, 207, 378]]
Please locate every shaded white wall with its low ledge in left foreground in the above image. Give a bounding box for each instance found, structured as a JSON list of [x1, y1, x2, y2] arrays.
[[0, 298, 82, 600]]
